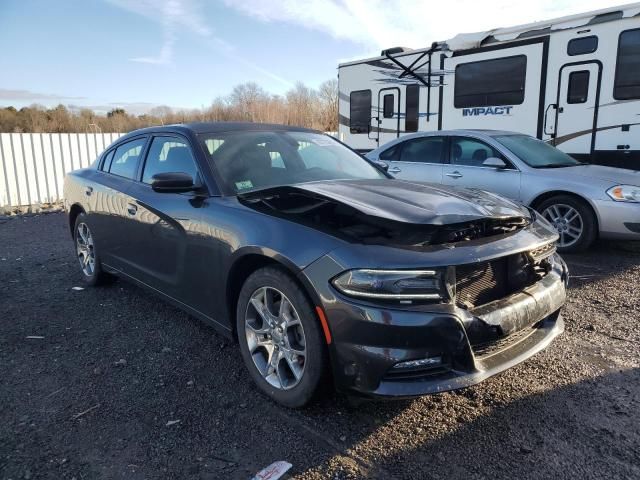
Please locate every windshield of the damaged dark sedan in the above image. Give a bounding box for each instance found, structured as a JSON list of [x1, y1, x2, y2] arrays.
[[202, 131, 387, 193]]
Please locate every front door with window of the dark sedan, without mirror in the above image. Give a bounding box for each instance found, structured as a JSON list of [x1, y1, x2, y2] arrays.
[[126, 135, 208, 308]]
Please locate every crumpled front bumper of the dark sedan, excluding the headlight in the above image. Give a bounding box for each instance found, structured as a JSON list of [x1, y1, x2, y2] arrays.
[[303, 218, 568, 397]]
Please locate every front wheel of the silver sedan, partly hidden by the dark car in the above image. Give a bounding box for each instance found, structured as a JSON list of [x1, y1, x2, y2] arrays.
[[536, 195, 598, 253]]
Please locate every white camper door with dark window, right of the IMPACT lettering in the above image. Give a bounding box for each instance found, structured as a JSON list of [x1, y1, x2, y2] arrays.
[[554, 62, 601, 154]]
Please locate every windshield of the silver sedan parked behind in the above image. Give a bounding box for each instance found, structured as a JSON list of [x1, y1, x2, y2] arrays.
[[494, 135, 581, 168]]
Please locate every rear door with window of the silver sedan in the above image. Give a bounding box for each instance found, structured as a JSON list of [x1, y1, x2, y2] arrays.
[[379, 135, 447, 183]]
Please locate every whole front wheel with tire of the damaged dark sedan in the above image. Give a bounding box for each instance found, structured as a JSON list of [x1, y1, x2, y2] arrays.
[[236, 267, 329, 408]]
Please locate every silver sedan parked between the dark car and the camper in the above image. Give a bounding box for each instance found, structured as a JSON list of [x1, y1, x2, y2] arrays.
[[367, 130, 640, 252]]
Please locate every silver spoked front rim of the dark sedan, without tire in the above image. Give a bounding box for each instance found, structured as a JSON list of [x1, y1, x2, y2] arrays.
[[245, 287, 307, 390]]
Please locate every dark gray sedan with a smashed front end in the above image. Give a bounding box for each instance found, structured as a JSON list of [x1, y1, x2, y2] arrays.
[[64, 123, 568, 407]]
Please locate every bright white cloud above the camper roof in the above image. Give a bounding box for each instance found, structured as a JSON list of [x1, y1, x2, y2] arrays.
[[223, 0, 619, 53]]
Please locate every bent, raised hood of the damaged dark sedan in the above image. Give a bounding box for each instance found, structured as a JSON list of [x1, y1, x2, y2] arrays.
[[238, 179, 530, 225]]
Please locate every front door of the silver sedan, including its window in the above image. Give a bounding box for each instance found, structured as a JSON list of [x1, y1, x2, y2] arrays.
[[443, 136, 520, 201]]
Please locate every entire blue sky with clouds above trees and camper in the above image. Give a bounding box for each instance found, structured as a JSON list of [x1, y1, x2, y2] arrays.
[[0, 0, 617, 113]]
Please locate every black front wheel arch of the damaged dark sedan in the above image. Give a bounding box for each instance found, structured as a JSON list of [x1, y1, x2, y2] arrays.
[[225, 250, 321, 341]]
